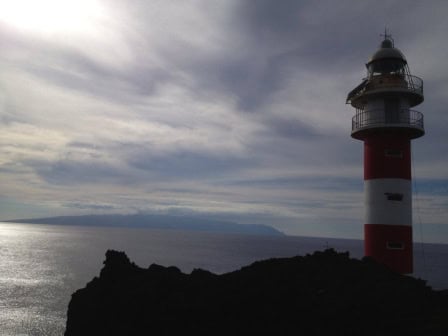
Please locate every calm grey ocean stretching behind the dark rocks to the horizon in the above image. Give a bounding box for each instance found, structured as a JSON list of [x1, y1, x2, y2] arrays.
[[0, 223, 448, 336]]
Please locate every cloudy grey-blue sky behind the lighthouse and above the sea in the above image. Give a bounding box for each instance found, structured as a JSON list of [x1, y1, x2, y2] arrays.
[[0, 0, 448, 243]]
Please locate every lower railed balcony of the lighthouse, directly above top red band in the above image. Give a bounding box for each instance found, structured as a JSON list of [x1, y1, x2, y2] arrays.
[[351, 110, 425, 139]]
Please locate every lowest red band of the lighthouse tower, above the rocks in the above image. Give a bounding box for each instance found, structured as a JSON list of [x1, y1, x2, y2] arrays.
[[364, 224, 413, 274]]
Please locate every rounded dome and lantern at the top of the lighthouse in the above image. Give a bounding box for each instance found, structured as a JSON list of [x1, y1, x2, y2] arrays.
[[366, 38, 407, 74]]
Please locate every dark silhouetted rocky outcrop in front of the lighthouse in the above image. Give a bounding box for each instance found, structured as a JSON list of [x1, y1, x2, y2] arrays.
[[65, 250, 448, 336]]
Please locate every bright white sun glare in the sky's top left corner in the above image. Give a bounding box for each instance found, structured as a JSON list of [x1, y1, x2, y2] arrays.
[[0, 0, 104, 34]]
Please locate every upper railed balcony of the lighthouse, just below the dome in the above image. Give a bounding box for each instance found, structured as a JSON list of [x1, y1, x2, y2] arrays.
[[347, 74, 424, 108]]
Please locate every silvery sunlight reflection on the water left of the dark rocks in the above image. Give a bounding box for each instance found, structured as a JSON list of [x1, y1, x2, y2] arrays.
[[0, 225, 70, 335]]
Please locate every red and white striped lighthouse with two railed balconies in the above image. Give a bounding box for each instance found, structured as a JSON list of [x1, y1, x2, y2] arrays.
[[347, 32, 425, 273]]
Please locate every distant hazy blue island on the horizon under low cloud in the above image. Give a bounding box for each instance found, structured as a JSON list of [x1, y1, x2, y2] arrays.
[[6, 214, 284, 236]]
